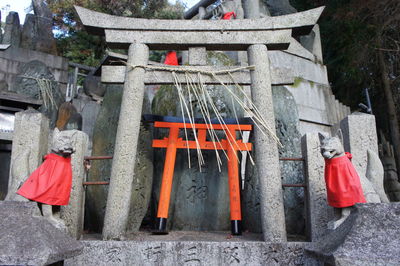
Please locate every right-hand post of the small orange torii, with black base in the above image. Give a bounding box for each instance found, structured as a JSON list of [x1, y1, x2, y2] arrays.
[[225, 125, 242, 235]]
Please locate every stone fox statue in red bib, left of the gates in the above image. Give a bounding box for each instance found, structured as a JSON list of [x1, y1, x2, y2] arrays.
[[17, 128, 74, 228]]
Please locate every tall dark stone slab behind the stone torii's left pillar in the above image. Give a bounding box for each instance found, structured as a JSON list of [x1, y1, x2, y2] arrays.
[[85, 85, 153, 232]]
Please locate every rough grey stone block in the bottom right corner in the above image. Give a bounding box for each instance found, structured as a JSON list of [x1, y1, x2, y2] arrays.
[[307, 203, 400, 266]]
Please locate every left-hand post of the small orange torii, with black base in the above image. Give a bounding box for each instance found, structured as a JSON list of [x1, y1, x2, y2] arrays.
[[154, 126, 179, 234]]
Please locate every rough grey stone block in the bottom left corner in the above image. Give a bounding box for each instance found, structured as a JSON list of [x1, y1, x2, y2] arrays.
[[0, 201, 83, 265]]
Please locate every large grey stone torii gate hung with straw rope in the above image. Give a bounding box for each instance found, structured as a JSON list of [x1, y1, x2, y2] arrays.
[[75, 7, 323, 242]]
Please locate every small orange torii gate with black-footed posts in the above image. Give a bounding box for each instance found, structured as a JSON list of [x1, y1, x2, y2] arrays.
[[153, 121, 252, 235]]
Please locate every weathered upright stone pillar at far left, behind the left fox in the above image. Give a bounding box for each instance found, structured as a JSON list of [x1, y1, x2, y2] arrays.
[[6, 110, 49, 201]]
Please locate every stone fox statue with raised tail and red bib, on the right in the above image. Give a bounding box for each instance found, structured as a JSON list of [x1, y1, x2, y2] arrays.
[[318, 129, 389, 230]]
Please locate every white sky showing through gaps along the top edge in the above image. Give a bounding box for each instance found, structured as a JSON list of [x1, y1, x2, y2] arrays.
[[0, 0, 199, 24]]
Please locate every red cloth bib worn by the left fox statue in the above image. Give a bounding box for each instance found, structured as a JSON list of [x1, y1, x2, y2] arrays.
[[17, 153, 72, 205]]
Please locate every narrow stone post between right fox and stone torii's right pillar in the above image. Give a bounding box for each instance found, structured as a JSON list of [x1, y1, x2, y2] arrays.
[[302, 133, 332, 242]]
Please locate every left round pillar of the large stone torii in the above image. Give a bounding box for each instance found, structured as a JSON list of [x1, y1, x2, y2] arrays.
[[103, 43, 149, 239]]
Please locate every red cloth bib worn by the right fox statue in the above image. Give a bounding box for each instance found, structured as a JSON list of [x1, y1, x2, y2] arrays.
[[325, 152, 366, 208]]
